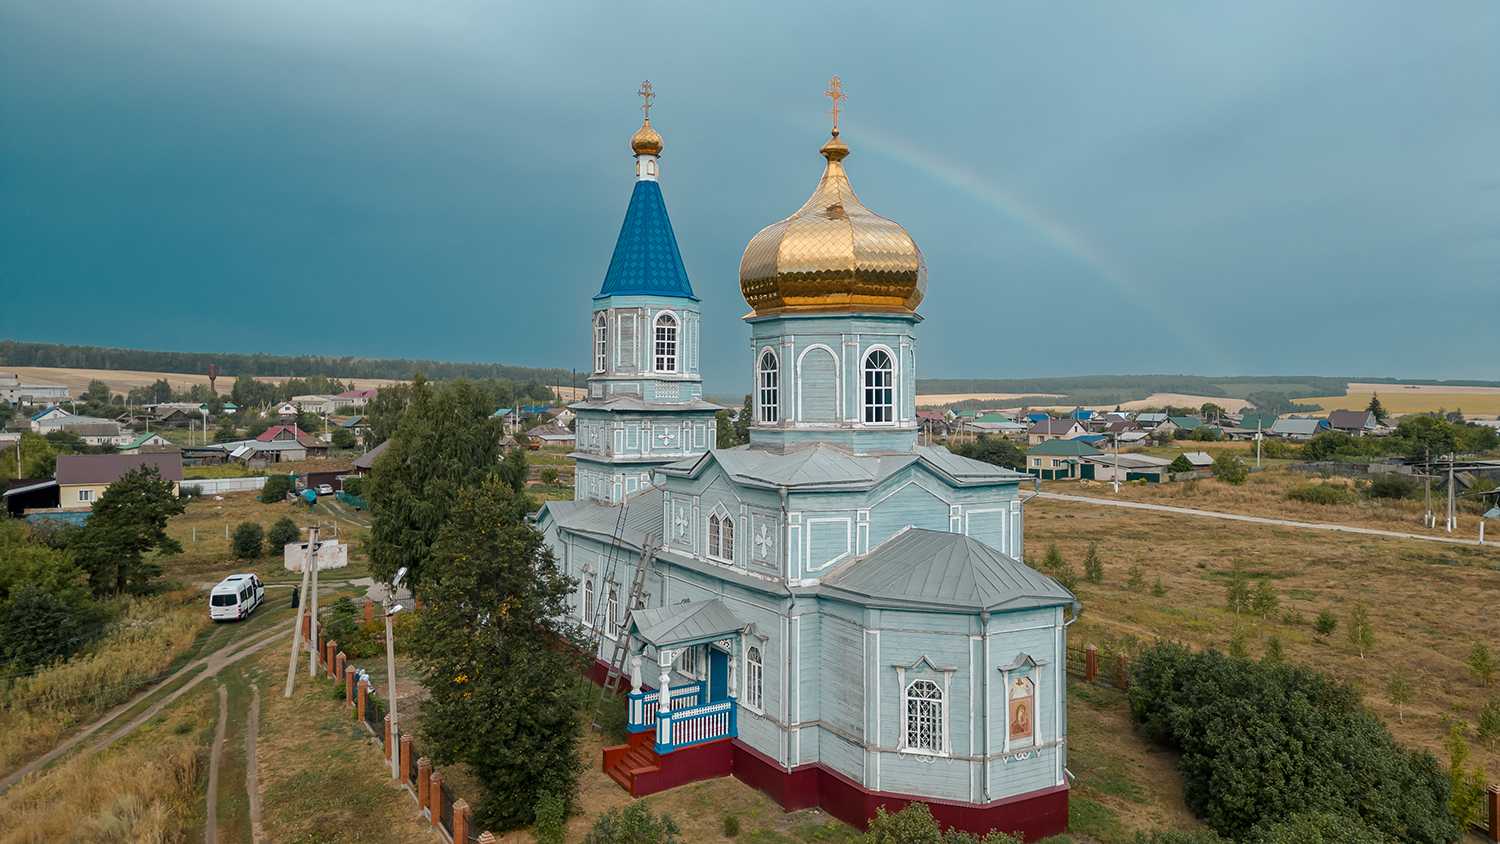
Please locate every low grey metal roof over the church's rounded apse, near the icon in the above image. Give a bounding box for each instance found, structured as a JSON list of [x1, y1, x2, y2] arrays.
[[821, 528, 1077, 612]]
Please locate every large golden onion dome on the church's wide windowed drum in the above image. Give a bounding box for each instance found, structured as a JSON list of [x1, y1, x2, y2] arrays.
[[740, 129, 927, 316]]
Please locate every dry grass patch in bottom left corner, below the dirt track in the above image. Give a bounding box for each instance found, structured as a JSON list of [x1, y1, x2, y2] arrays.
[[0, 683, 213, 844]]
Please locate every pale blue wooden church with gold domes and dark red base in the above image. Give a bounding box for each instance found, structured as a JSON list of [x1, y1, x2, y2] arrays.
[[537, 78, 1080, 841]]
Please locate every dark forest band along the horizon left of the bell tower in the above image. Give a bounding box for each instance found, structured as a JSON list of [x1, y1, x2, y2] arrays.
[[0, 340, 573, 385]]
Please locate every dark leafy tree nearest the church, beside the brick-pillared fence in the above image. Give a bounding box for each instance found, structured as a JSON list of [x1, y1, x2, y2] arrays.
[[414, 479, 584, 829]]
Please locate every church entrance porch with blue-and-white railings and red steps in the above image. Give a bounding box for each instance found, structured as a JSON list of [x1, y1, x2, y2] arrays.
[[603, 598, 746, 796]]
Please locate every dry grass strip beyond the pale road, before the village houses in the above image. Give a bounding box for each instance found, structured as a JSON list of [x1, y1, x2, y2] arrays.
[[1043, 464, 1500, 539]]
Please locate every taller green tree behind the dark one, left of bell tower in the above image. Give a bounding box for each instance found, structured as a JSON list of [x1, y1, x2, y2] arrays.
[[366, 379, 504, 590]]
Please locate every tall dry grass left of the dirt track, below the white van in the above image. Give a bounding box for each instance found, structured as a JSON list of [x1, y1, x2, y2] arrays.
[[0, 592, 209, 771]]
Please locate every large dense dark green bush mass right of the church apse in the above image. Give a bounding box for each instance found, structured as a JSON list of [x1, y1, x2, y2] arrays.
[[1128, 643, 1460, 844]]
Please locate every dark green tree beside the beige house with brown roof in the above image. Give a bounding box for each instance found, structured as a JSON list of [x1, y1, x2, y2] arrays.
[[69, 466, 188, 595]]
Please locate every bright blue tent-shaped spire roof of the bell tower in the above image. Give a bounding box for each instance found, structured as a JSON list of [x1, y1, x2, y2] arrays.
[[594, 180, 698, 301]]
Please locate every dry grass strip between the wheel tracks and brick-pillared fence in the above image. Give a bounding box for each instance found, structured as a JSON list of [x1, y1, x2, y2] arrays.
[[251, 648, 440, 844]]
